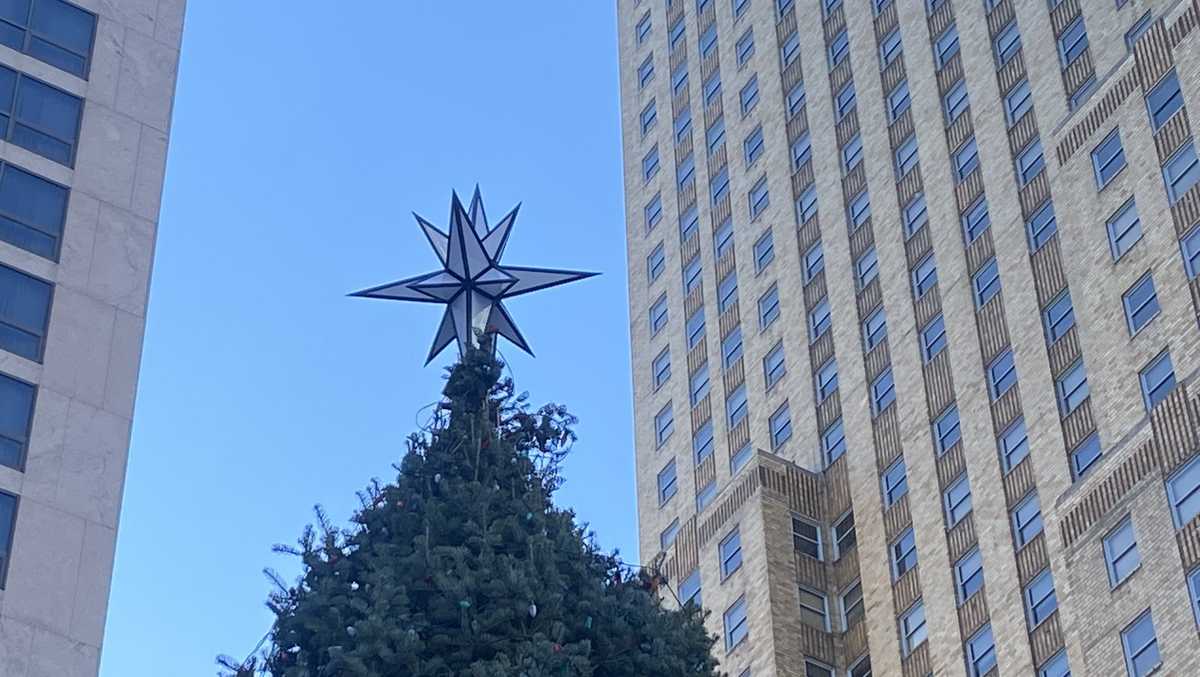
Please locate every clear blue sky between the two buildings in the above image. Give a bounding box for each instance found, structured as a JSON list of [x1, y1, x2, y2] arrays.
[[101, 0, 636, 677]]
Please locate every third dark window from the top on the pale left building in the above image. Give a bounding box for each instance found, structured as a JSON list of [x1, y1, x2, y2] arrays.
[[0, 160, 68, 260]]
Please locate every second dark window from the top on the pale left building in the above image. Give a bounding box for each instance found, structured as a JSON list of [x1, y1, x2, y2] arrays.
[[0, 67, 83, 167]]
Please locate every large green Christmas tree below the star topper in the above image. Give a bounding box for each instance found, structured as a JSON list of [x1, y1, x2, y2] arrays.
[[223, 345, 716, 677]]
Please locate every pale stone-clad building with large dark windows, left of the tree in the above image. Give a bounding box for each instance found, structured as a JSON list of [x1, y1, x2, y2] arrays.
[[0, 0, 185, 677]]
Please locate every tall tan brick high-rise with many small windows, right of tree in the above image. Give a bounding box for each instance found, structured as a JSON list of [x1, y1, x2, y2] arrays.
[[618, 0, 1200, 677]]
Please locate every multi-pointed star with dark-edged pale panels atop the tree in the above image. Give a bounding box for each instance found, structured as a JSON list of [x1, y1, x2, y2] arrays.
[[350, 186, 596, 364]]
